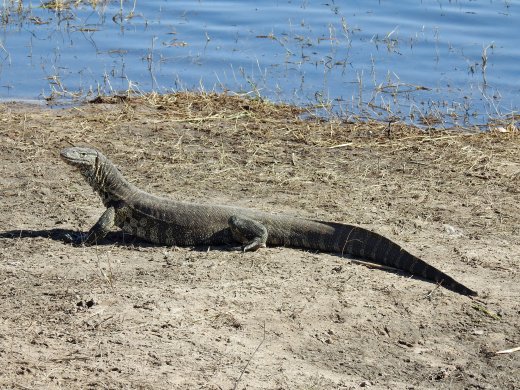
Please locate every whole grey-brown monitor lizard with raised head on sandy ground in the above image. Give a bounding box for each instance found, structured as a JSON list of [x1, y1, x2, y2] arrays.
[[61, 147, 477, 296]]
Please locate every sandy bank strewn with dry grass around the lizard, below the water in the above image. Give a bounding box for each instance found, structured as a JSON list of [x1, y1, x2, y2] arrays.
[[0, 94, 520, 389]]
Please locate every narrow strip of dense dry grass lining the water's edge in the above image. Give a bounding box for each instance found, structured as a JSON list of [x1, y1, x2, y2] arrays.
[[84, 92, 520, 142]]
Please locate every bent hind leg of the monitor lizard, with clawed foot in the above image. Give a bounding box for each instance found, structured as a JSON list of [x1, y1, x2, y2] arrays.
[[228, 215, 267, 252]]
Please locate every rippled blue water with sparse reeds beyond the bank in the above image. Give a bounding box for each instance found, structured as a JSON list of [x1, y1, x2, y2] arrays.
[[0, 0, 520, 124]]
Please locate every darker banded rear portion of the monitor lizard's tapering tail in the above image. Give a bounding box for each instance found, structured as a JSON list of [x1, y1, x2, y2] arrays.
[[319, 221, 477, 296]]
